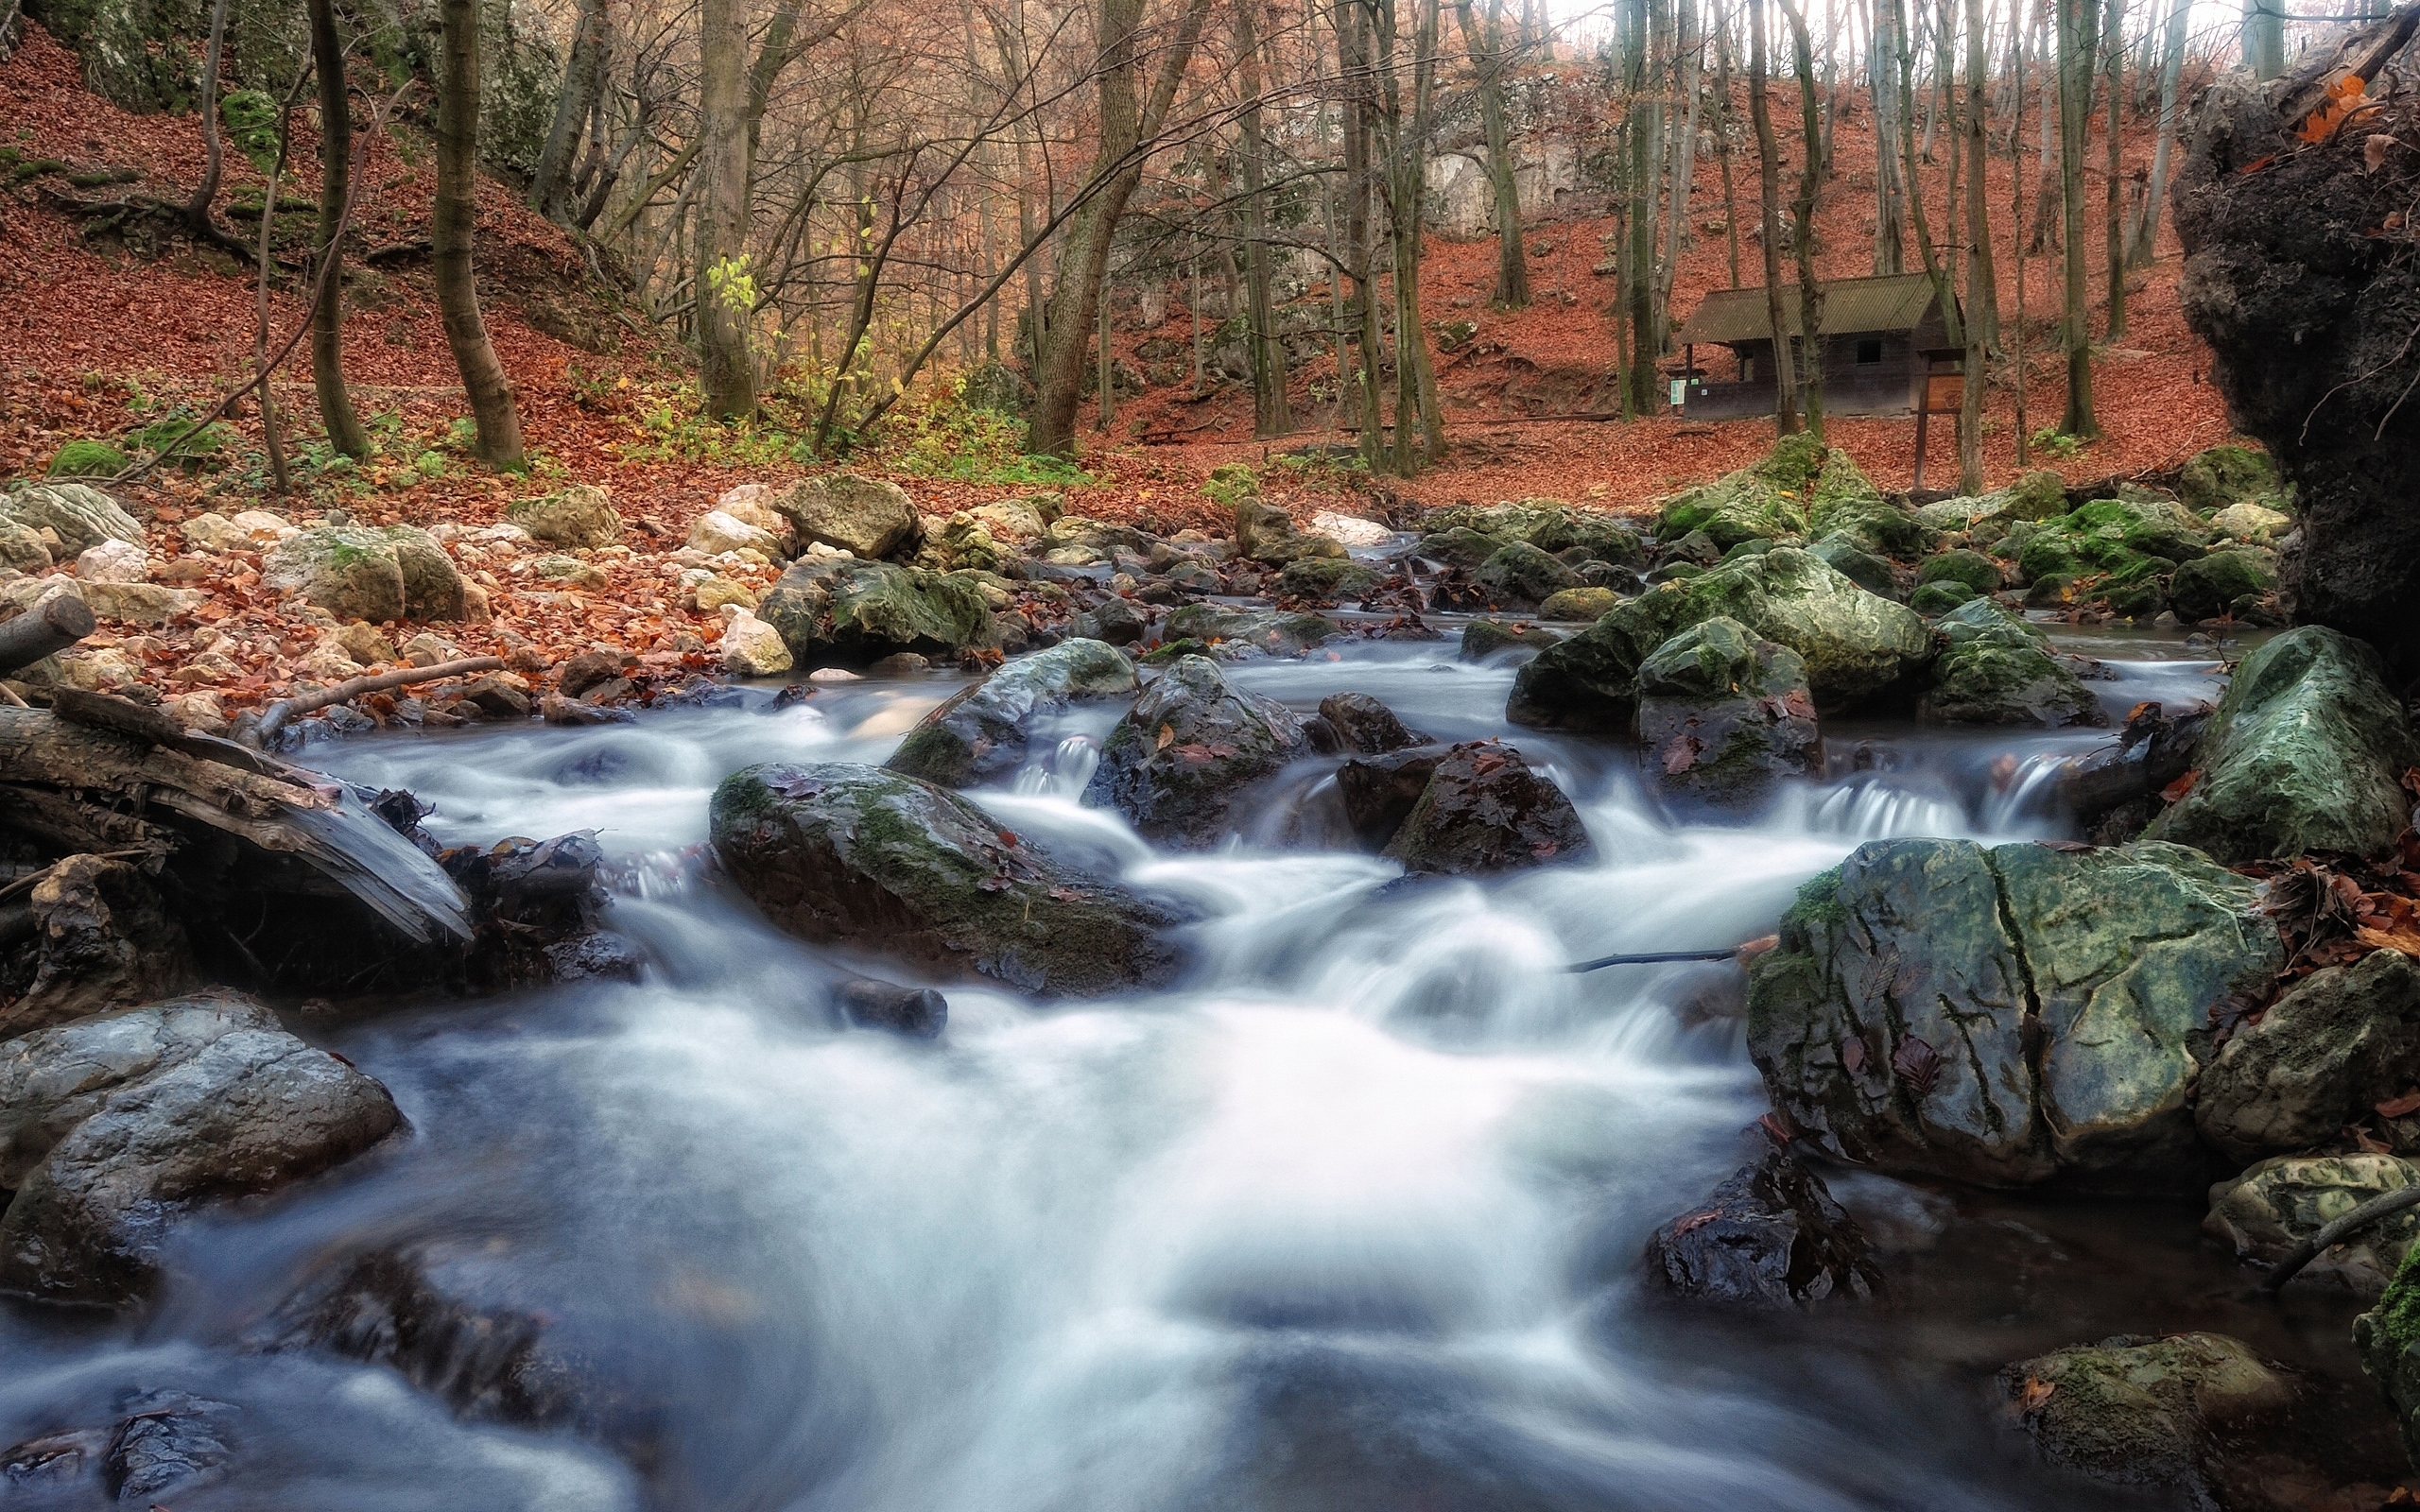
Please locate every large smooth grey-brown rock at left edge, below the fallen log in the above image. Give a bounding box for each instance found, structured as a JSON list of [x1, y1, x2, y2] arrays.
[[0, 999, 402, 1304]]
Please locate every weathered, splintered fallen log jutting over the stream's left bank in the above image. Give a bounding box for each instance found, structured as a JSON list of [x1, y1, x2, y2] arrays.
[[0, 695, 472, 943]]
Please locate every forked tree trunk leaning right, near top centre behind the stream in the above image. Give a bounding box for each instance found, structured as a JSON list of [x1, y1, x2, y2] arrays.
[[1026, 0, 1210, 457]]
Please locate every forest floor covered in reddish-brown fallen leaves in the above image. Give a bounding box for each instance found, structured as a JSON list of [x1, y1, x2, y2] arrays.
[[0, 25, 2229, 712]]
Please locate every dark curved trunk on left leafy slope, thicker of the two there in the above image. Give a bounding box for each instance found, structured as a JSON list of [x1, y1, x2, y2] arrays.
[[428, 0, 520, 467]]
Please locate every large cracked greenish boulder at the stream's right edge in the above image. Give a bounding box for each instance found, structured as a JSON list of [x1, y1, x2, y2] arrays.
[[1747, 839, 2282, 1191]]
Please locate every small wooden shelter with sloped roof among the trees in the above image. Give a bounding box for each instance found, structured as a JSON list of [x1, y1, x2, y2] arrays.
[[1672, 273, 1962, 421]]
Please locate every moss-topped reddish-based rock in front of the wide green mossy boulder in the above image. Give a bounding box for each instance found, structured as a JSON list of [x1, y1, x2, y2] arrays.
[[1636, 617, 1823, 808]]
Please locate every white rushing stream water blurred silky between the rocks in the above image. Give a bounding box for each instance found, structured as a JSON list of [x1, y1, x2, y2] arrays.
[[0, 624, 2381, 1512]]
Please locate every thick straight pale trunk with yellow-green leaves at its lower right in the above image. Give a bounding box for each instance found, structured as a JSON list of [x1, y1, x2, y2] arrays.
[[695, 0, 757, 421]]
